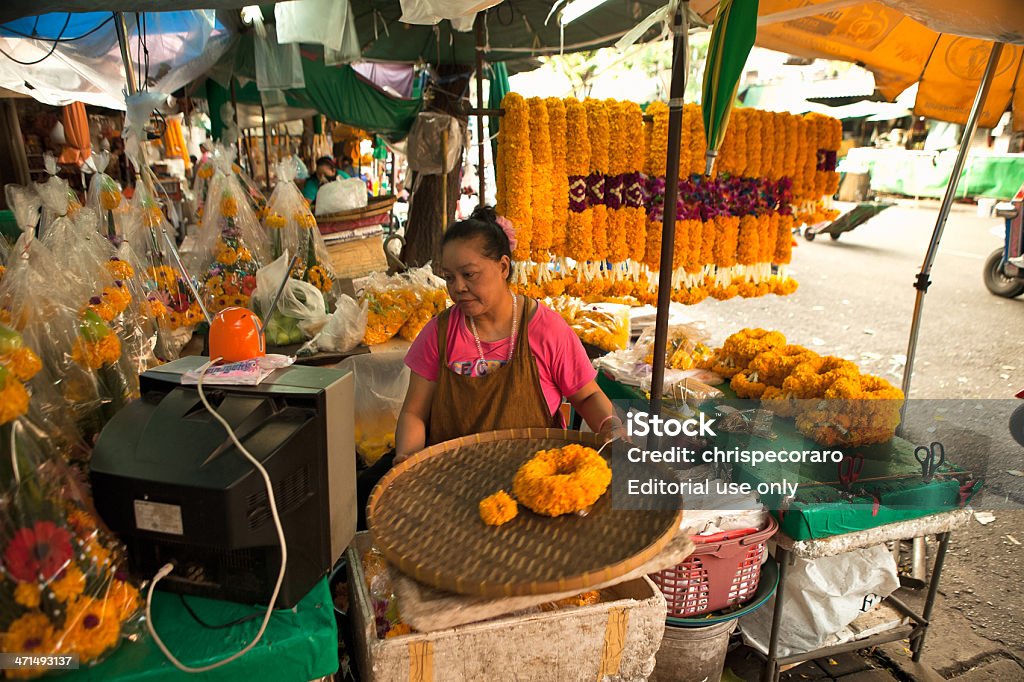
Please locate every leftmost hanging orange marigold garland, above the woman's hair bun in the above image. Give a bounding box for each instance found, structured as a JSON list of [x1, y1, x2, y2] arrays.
[[499, 92, 534, 261]]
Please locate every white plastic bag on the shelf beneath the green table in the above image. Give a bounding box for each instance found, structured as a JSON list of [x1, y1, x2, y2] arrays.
[[739, 545, 899, 656]]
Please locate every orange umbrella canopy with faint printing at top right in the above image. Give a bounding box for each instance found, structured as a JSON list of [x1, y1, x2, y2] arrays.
[[692, 0, 1024, 130]]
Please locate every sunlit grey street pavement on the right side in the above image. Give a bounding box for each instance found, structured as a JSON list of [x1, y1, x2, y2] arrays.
[[700, 201, 1024, 682]]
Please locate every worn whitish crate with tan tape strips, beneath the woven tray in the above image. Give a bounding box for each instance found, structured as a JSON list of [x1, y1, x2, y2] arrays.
[[345, 532, 666, 682]]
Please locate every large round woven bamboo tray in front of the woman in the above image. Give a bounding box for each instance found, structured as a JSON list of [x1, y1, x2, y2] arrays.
[[367, 429, 683, 597]]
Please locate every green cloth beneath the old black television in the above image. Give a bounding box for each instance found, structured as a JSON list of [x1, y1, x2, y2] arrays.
[[67, 578, 338, 682]]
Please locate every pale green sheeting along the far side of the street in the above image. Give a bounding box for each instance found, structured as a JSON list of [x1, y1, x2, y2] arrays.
[[840, 147, 1024, 200]]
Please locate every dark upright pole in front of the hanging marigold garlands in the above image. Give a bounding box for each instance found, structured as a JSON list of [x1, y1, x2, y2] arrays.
[[650, 0, 689, 415]]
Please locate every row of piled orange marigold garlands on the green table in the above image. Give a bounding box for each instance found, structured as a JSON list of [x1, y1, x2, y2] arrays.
[[702, 329, 904, 446]]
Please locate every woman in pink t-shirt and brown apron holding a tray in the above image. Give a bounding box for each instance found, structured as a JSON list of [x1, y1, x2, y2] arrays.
[[395, 208, 623, 463]]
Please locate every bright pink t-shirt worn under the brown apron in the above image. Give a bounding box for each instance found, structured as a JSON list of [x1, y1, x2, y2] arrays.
[[406, 303, 597, 415]]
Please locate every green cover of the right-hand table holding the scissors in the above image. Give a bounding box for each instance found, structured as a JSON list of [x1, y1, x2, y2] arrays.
[[598, 372, 981, 540]]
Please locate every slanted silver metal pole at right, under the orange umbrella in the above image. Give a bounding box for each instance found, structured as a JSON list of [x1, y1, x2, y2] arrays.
[[900, 43, 1002, 403]]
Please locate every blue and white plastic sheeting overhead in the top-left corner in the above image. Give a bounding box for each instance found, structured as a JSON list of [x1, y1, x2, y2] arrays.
[[0, 10, 232, 111]]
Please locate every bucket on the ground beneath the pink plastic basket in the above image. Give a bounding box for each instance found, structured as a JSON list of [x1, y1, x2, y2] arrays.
[[649, 621, 736, 682]]
